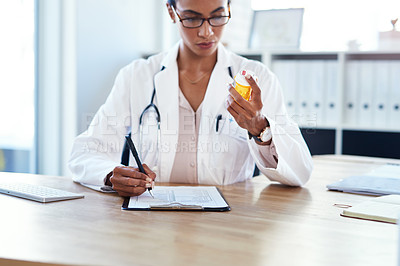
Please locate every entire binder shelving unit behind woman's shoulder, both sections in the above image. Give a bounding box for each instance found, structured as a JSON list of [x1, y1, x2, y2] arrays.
[[263, 52, 400, 158]]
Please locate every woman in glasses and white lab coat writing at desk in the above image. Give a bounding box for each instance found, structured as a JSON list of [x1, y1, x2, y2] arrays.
[[69, 0, 313, 196]]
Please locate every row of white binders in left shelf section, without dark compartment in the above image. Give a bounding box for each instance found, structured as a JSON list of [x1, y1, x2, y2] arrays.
[[271, 53, 340, 128]]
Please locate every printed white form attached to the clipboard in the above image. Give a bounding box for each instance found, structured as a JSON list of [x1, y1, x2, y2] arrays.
[[128, 186, 228, 209]]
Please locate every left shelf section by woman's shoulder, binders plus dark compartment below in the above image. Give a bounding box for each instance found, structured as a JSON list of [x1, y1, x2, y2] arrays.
[[238, 51, 340, 155]]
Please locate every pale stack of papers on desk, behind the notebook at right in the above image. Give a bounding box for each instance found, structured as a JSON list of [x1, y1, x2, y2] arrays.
[[326, 164, 400, 195]]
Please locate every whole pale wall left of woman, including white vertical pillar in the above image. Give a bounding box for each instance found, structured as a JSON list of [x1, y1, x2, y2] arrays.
[[36, 0, 166, 176]]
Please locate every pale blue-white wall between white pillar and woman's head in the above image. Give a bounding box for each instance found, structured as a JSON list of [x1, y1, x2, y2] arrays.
[[77, 0, 164, 132]]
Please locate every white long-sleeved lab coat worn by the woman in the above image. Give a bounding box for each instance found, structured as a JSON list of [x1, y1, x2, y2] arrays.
[[69, 43, 313, 186]]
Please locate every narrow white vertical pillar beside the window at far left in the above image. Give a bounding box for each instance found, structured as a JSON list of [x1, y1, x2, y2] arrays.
[[35, 0, 62, 175]]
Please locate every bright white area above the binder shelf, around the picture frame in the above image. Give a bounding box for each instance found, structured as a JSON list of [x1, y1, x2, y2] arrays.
[[251, 0, 400, 51]]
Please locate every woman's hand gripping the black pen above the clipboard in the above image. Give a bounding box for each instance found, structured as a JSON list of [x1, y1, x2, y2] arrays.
[[110, 164, 156, 197]]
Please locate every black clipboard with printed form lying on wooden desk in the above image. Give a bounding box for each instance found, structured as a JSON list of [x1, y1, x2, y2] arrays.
[[121, 186, 231, 212]]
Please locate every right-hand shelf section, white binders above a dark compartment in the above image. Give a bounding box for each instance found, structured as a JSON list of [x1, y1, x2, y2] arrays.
[[342, 52, 400, 158]]
